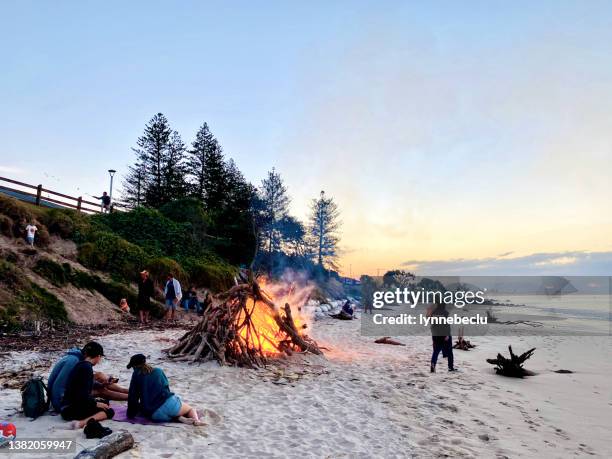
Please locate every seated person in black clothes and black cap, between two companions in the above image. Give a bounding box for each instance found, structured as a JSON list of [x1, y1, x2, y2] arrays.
[[61, 343, 115, 429]]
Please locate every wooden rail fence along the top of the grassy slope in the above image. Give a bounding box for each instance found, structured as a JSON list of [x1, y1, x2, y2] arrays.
[[0, 177, 126, 214]]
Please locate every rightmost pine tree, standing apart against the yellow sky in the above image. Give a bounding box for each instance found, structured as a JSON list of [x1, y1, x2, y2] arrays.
[[310, 191, 340, 268]]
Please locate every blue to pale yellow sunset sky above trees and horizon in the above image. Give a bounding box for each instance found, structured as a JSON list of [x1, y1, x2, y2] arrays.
[[0, 0, 612, 276]]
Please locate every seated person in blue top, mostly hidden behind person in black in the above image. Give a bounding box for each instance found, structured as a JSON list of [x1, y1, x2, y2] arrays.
[[47, 341, 128, 413]]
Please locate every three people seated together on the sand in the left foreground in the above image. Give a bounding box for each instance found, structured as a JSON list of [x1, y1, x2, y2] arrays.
[[48, 341, 202, 437]]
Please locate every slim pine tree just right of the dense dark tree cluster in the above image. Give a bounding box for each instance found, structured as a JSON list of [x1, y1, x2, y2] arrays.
[[260, 168, 290, 253]]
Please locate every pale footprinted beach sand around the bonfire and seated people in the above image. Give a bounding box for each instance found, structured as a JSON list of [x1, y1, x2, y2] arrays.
[[0, 319, 612, 458]]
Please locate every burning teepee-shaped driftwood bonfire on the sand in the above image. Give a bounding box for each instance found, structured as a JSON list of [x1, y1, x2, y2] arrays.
[[168, 280, 321, 368]]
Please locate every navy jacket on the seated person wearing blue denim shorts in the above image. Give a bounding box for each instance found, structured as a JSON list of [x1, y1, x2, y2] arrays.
[[127, 368, 174, 418]]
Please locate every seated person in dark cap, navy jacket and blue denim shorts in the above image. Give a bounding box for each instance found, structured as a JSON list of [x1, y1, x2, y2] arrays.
[[127, 354, 203, 425]]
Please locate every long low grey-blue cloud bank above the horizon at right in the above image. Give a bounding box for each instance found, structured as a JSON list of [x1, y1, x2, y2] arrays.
[[402, 251, 612, 276]]
